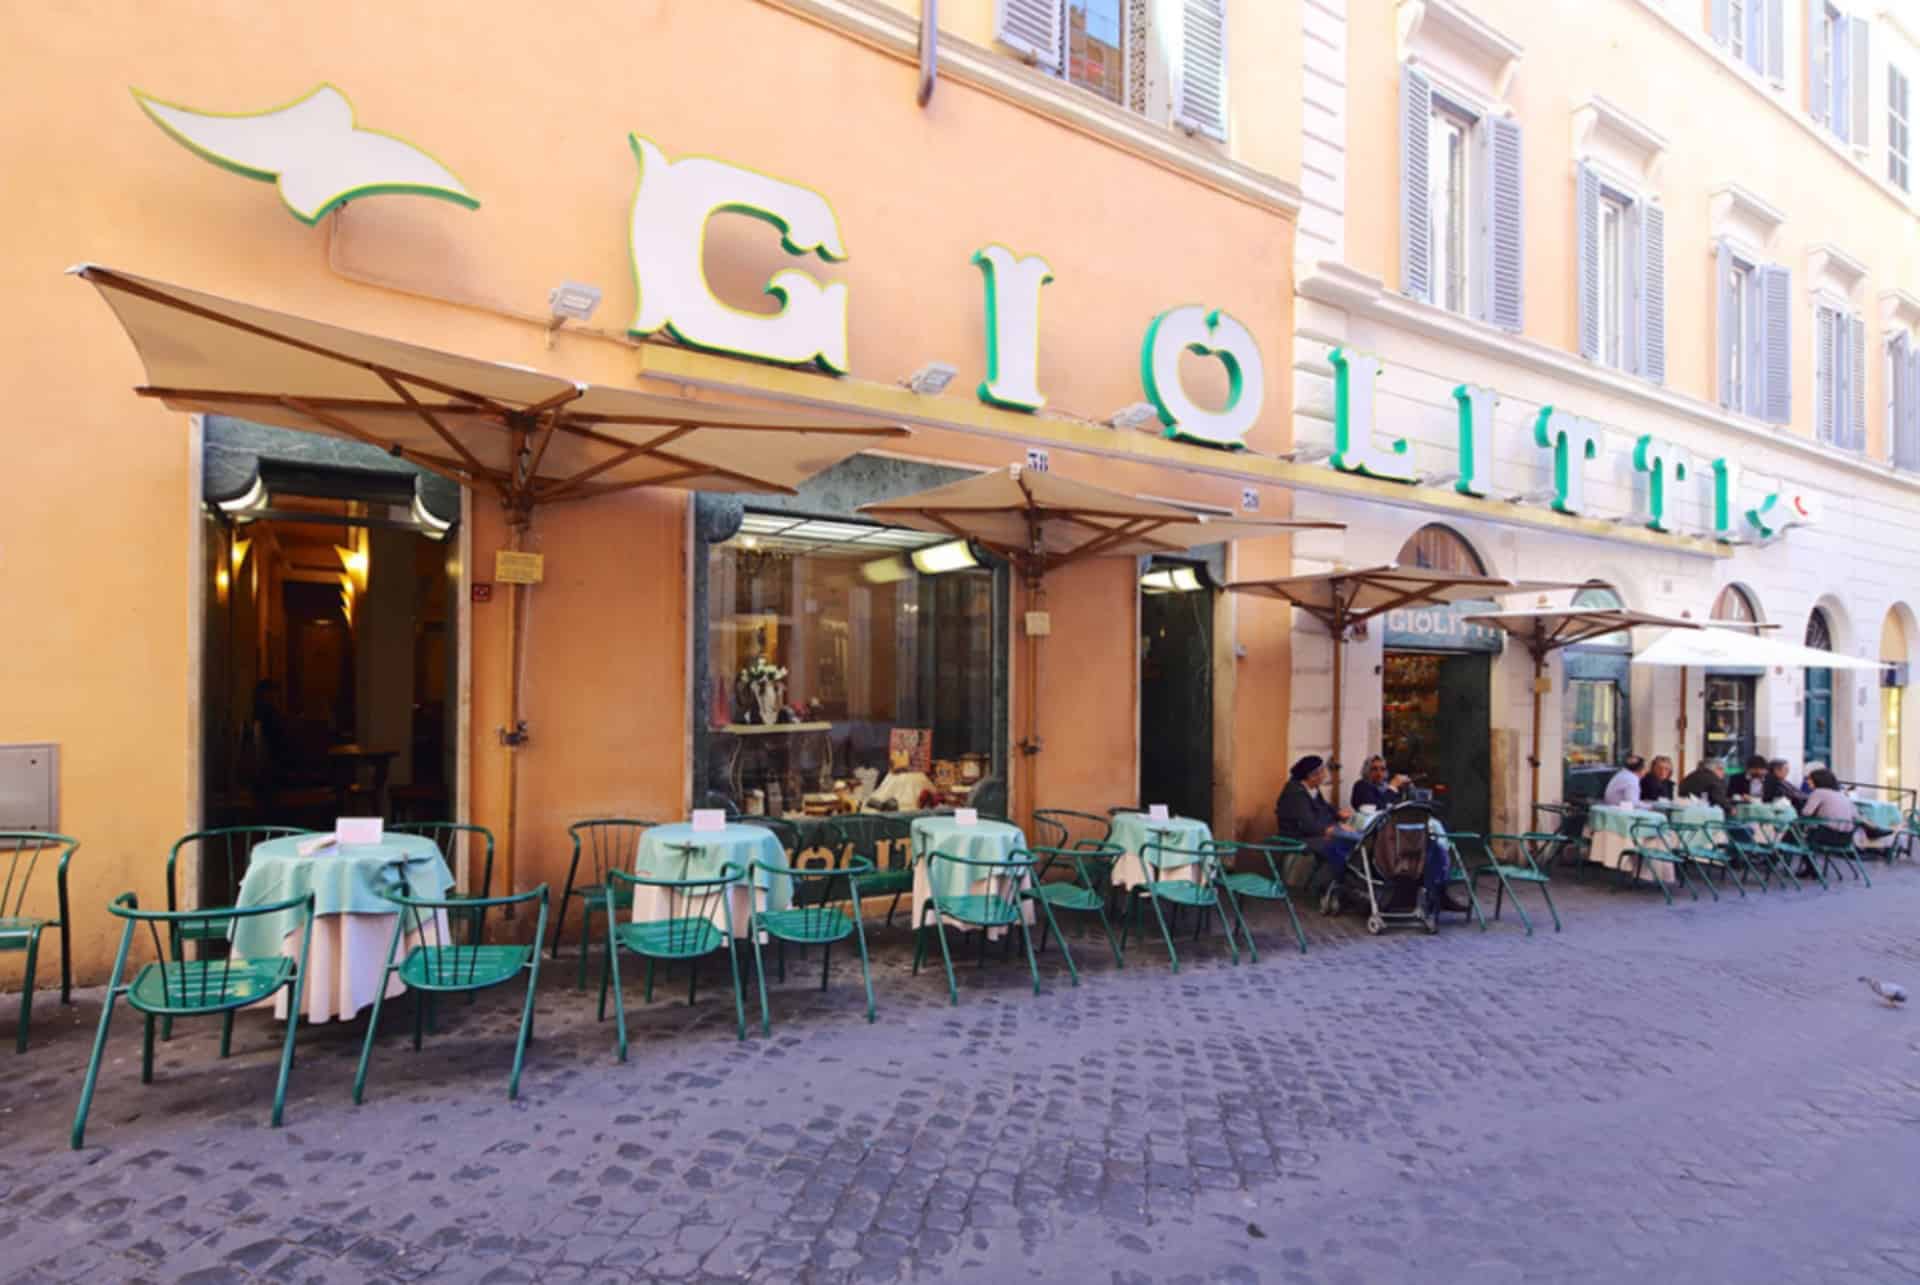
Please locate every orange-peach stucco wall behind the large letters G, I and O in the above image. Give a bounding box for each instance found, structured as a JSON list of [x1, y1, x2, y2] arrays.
[[0, 0, 1292, 978]]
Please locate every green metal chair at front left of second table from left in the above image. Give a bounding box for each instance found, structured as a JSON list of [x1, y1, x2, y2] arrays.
[[599, 856, 747, 1062]]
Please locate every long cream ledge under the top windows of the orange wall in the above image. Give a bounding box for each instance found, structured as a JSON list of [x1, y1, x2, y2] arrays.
[[760, 0, 1300, 219]]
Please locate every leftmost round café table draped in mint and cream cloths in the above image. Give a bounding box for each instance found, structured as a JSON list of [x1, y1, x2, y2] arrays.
[[232, 834, 453, 1022]]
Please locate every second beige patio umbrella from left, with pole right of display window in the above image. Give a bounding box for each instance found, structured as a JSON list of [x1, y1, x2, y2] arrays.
[[860, 465, 1344, 810]]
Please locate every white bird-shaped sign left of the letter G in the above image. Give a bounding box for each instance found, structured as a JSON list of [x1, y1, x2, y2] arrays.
[[132, 85, 480, 225]]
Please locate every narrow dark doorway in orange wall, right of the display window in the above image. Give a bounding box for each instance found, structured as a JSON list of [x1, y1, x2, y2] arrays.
[[1140, 559, 1213, 820]]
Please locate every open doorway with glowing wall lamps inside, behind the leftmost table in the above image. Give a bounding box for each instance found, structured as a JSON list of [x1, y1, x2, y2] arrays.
[[202, 459, 459, 872]]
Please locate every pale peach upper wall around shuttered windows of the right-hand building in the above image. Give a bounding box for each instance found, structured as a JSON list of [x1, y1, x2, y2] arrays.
[[1346, 0, 1920, 459]]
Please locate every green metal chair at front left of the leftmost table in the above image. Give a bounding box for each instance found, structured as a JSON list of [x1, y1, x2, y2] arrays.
[[71, 893, 313, 1151]]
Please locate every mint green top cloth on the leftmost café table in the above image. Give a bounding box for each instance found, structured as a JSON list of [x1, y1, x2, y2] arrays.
[[232, 834, 453, 958]]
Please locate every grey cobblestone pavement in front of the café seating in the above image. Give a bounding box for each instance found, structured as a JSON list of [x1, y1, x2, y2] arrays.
[[0, 868, 1920, 1285]]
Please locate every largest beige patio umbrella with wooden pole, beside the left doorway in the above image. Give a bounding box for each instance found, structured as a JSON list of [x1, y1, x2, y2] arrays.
[[71, 265, 906, 891]]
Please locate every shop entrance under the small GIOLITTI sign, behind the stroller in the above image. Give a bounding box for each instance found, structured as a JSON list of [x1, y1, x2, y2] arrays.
[[1380, 647, 1494, 834]]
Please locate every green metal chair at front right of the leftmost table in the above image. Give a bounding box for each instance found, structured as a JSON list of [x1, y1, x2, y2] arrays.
[[353, 884, 547, 1106]]
